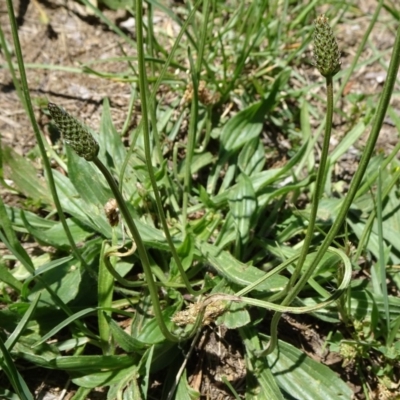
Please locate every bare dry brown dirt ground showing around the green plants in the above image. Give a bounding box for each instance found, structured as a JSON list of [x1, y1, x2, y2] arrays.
[[0, 0, 400, 399]]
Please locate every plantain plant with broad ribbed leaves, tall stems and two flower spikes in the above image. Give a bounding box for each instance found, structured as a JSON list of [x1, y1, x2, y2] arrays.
[[0, 0, 400, 399]]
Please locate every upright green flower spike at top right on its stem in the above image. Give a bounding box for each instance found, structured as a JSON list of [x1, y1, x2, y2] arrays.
[[314, 15, 341, 77]]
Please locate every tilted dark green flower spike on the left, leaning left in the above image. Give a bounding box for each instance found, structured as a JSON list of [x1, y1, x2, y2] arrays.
[[47, 103, 99, 161]]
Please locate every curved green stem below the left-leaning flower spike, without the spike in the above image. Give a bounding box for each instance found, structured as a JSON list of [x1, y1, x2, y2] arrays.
[[93, 157, 179, 342]]
